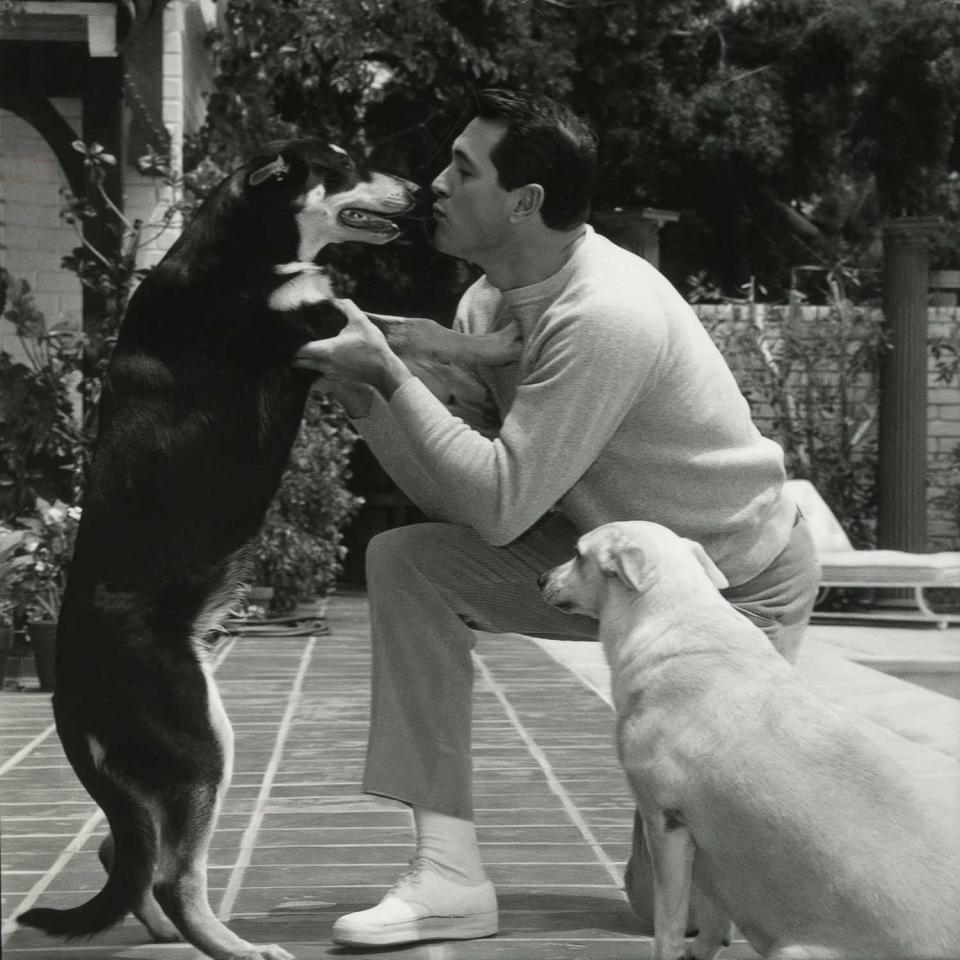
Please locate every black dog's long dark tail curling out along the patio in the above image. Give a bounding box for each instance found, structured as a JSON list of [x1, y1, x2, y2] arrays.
[[17, 774, 157, 940]]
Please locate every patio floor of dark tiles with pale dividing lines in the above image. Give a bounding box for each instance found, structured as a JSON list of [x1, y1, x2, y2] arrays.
[[0, 595, 946, 960]]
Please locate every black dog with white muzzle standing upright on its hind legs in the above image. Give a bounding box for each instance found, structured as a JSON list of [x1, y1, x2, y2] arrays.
[[18, 140, 516, 960]]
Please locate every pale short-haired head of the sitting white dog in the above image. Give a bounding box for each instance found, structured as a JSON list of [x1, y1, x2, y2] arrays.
[[537, 520, 729, 617]]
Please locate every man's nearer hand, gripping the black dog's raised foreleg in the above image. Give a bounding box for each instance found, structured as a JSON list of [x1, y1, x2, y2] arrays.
[[293, 300, 411, 400]]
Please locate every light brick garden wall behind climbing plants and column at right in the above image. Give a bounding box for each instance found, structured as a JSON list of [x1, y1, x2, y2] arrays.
[[694, 304, 960, 550]]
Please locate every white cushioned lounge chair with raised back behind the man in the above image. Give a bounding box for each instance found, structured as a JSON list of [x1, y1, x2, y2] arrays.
[[786, 480, 960, 629]]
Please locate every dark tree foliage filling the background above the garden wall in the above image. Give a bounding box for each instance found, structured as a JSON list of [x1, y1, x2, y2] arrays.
[[201, 0, 960, 304]]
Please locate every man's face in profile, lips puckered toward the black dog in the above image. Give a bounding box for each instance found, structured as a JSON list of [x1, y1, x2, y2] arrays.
[[433, 118, 513, 266]]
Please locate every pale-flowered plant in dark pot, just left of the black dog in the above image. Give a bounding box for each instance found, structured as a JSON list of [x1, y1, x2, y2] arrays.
[[13, 497, 80, 691]]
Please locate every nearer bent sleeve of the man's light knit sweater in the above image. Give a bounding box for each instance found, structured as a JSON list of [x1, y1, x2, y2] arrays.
[[389, 303, 663, 545]]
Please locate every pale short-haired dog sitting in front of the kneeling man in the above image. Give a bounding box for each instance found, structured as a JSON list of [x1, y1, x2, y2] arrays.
[[540, 522, 960, 960]]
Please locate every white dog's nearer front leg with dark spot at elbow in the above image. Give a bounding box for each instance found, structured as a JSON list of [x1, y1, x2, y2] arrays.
[[642, 808, 696, 960]]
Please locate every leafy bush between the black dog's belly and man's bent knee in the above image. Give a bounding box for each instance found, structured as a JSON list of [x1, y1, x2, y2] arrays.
[[254, 394, 362, 615]]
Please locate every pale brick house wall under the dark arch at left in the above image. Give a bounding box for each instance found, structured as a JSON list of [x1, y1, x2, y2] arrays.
[[0, 99, 83, 364]]
